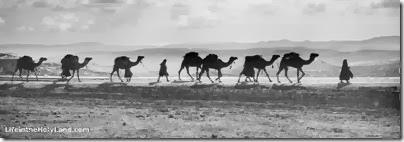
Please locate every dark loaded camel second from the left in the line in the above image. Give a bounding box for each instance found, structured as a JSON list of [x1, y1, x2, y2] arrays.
[[61, 54, 93, 83]]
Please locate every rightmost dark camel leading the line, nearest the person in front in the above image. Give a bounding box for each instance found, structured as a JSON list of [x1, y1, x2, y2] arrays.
[[276, 52, 319, 83]]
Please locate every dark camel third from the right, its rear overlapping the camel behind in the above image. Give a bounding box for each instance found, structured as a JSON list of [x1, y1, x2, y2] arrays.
[[198, 54, 238, 83]]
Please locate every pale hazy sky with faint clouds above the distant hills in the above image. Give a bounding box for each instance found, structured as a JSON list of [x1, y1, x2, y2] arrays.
[[0, 0, 400, 44]]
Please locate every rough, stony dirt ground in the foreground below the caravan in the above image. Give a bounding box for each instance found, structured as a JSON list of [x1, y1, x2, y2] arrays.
[[0, 83, 401, 139]]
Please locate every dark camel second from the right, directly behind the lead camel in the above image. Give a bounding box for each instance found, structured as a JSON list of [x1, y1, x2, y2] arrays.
[[239, 55, 280, 82]]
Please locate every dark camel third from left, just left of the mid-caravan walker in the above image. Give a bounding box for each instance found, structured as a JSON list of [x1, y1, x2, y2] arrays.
[[109, 56, 144, 82]]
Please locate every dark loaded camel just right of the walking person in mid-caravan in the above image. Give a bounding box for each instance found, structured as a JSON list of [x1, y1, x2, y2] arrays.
[[178, 52, 202, 82]]
